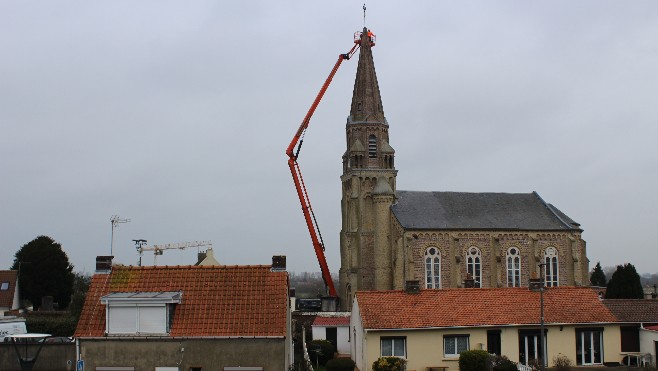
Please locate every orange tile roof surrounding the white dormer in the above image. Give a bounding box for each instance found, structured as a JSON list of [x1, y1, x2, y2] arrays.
[[75, 265, 288, 337]]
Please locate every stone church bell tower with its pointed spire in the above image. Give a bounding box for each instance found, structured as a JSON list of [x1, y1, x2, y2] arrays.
[[339, 28, 397, 310]]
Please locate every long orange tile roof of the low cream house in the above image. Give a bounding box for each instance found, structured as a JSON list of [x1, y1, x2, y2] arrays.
[[356, 287, 616, 329]]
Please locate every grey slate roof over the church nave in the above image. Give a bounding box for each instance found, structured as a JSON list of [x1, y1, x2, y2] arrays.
[[391, 191, 581, 231]]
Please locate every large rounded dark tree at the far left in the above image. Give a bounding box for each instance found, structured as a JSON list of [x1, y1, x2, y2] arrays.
[[11, 236, 74, 310]]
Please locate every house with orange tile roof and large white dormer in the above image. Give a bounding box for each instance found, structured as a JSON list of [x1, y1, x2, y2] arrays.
[[75, 257, 292, 371]]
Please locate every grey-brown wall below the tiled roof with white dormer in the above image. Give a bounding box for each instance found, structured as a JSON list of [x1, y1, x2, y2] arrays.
[[79, 338, 289, 371]]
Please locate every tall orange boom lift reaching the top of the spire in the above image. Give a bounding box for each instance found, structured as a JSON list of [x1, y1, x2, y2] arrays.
[[286, 32, 374, 297]]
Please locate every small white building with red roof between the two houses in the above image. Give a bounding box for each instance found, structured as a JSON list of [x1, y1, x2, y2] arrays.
[[311, 312, 350, 356]]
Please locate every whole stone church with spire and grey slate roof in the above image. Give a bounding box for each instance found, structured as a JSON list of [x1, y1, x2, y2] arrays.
[[339, 28, 589, 310]]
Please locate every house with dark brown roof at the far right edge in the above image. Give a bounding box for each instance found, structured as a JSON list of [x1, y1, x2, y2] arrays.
[[603, 299, 658, 359]]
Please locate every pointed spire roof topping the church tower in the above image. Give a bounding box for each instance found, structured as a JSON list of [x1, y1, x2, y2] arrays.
[[350, 27, 386, 124]]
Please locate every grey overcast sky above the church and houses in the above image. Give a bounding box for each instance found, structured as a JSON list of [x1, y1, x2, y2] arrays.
[[0, 0, 658, 273]]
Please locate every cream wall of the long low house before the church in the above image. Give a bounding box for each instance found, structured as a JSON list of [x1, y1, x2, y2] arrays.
[[353, 325, 621, 370]]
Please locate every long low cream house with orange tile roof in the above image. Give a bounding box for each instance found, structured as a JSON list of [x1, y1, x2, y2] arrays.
[[350, 286, 621, 370]]
